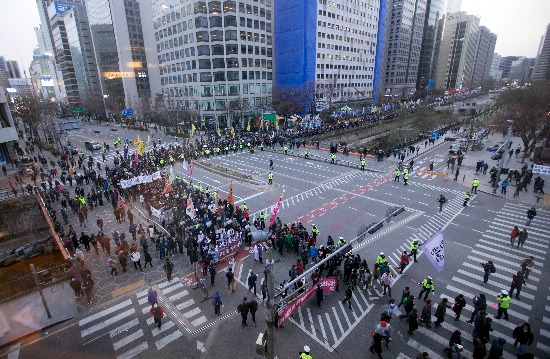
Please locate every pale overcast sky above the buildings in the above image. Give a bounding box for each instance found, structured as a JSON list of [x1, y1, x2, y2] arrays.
[[0, 0, 550, 76]]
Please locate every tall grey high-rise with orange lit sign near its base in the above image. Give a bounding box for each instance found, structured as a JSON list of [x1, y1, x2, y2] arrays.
[[86, 0, 160, 115]]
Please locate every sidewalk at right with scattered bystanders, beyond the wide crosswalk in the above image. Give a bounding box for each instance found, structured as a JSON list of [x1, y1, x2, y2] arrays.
[[445, 133, 550, 207]]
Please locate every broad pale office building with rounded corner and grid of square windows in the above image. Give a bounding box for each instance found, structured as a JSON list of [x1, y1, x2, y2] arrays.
[[153, 0, 273, 127]]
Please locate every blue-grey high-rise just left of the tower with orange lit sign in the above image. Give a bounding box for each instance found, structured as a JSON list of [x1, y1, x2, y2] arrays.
[[48, 3, 99, 107]]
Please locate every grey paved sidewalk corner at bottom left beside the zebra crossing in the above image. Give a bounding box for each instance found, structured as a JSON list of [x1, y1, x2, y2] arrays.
[[0, 281, 78, 347]]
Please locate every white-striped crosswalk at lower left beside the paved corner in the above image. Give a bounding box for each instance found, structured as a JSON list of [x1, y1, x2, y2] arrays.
[[78, 277, 212, 359]]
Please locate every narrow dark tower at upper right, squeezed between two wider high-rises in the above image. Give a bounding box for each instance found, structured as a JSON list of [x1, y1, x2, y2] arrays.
[[416, 0, 452, 89]]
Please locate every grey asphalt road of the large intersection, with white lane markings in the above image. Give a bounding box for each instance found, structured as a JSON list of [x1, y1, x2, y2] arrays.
[[5, 125, 550, 358]]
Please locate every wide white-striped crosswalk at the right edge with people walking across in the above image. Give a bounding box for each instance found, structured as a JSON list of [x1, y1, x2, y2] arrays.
[[396, 199, 550, 359]]
